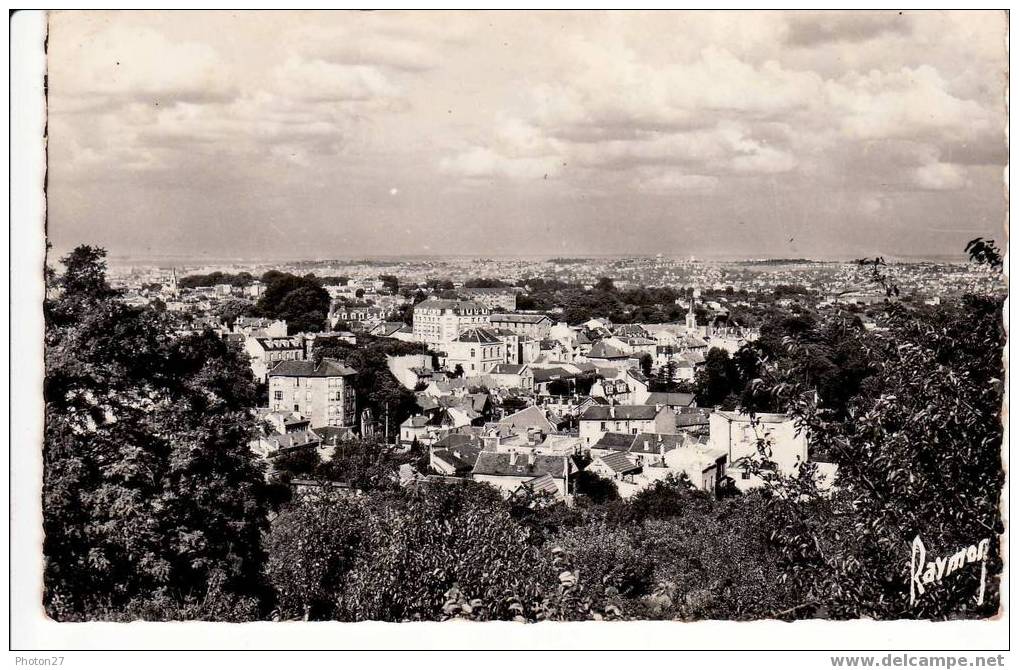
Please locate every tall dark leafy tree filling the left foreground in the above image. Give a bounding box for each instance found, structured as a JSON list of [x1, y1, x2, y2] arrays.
[[43, 247, 268, 620]]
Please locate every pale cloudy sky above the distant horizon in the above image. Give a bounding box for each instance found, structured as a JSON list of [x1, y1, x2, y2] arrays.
[[48, 12, 1007, 259]]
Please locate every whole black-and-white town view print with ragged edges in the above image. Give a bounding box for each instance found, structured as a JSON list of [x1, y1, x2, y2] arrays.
[[31, 10, 1009, 625]]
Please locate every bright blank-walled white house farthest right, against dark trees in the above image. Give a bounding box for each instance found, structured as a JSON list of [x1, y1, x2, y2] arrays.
[[709, 411, 808, 474]]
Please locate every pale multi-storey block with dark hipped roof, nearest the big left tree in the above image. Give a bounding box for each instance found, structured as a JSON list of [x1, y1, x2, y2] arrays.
[[269, 358, 357, 427]]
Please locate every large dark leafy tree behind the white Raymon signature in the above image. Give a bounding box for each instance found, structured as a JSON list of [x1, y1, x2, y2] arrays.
[[755, 247, 1005, 619]]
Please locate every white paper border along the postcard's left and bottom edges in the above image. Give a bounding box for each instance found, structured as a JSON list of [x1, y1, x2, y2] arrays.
[[3, 3, 1011, 651]]
